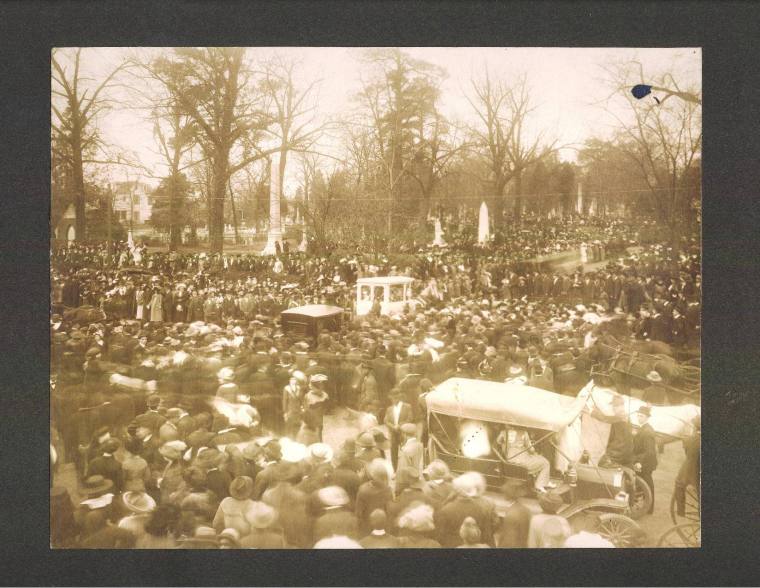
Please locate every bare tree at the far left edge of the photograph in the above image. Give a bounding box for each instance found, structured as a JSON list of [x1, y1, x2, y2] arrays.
[[51, 48, 126, 240]]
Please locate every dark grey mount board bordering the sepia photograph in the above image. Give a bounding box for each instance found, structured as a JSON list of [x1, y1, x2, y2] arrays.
[[0, 0, 760, 586]]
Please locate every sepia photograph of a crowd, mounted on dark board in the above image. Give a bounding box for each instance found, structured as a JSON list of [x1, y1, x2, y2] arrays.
[[47, 47, 709, 550]]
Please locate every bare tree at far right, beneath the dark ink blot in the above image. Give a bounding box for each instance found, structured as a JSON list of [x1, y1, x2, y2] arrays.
[[606, 61, 702, 252]]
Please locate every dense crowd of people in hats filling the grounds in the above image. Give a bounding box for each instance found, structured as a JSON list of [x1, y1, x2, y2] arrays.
[[51, 221, 701, 548]]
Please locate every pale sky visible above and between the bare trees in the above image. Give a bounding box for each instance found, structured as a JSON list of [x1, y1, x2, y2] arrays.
[[53, 47, 702, 193]]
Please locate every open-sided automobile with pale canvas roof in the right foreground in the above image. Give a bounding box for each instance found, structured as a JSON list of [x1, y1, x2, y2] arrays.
[[425, 377, 687, 544]]
